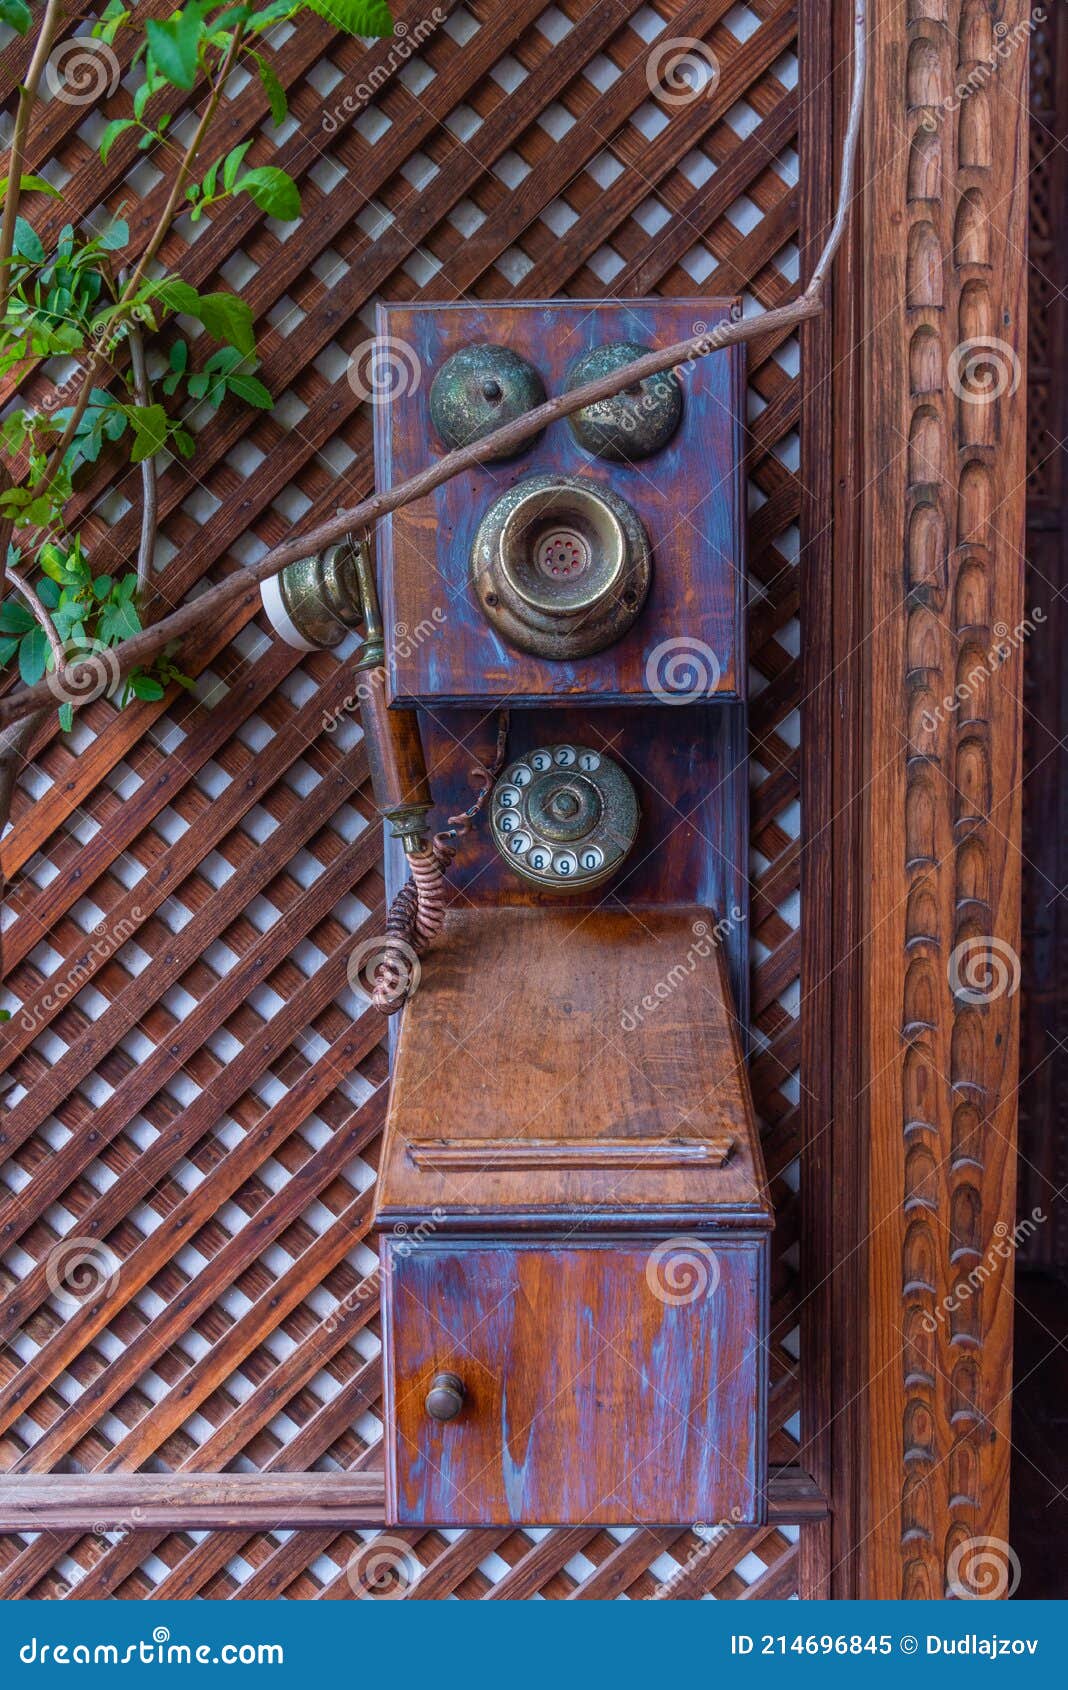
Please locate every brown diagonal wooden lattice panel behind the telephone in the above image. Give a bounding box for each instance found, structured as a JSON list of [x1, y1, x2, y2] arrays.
[[0, 0, 801, 1599]]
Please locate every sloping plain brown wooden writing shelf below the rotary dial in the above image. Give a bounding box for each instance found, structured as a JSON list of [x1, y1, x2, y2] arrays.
[[375, 904, 772, 1235]]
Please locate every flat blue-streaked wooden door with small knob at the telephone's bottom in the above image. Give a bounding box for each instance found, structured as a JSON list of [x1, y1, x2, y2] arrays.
[[384, 1235, 767, 1526]]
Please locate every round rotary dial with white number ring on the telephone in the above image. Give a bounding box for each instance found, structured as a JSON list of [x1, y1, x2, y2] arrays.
[[490, 745, 639, 892]]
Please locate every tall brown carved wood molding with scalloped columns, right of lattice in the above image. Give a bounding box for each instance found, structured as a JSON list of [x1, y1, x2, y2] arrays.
[[853, 0, 1036, 1599]]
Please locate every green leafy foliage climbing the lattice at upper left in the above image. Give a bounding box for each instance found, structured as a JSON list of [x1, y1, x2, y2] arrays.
[[0, 0, 392, 763]]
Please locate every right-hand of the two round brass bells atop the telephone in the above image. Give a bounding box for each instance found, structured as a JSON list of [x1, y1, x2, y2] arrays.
[[566, 340, 683, 463]]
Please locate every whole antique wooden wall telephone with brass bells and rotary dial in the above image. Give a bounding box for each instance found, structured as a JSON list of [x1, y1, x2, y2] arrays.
[[263, 301, 772, 1526]]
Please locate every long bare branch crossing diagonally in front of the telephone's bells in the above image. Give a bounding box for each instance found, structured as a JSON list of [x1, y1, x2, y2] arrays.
[[0, 0, 867, 728]]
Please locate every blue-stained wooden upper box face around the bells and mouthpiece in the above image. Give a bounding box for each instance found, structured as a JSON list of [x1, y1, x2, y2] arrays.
[[375, 299, 745, 705]]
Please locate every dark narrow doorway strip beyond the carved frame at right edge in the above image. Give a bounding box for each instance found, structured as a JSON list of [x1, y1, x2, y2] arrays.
[[1011, 7, 1068, 1597]]
